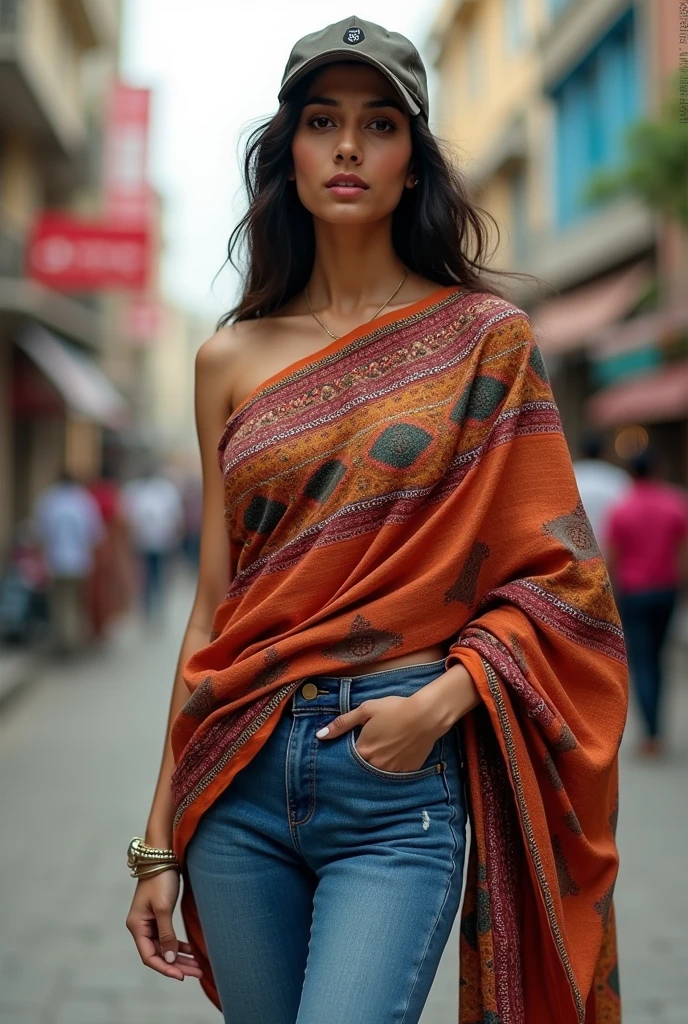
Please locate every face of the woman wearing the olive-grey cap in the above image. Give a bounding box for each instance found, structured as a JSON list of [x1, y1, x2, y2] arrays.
[[290, 61, 415, 224]]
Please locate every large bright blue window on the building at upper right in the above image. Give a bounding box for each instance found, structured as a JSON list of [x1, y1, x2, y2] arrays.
[[552, 9, 640, 225]]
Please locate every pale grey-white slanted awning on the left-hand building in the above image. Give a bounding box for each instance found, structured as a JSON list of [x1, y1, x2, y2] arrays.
[[14, 324, 129, 429]]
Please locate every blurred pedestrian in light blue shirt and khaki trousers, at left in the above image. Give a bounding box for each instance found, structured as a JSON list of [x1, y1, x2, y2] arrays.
[[34, 470, 105, 653]]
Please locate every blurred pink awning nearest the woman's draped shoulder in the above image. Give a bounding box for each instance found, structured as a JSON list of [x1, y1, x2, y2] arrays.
[[530, 263, 652, 355]]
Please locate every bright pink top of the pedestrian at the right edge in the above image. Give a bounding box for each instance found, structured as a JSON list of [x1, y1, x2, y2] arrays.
[[606, 479, 688, 594]]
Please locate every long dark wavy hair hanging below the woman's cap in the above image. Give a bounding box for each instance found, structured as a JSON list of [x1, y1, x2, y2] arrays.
[[211, 69, 518, 330]]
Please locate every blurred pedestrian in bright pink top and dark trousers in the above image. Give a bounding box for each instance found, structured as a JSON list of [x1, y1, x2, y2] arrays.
[[606, 453, 688, 757]]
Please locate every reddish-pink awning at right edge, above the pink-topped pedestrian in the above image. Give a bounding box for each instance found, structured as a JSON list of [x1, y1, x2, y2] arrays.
[[588, 362, 688, 428]]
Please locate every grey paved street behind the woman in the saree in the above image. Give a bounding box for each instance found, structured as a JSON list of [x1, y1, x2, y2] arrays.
[[0, 585, 688, 1024]]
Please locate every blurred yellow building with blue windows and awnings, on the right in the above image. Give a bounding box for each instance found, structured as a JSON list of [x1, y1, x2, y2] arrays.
[[430, 0, 688, 479]]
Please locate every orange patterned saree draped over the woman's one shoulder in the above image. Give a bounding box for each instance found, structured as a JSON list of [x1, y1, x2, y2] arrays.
[[172, 287, 628, 1024]]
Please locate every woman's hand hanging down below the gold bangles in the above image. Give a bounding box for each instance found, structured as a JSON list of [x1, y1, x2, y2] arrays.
[[127, 868, 203, 981]]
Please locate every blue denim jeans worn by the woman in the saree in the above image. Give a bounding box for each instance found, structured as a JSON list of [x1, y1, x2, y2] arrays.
[[186, 658, 466, 1024]]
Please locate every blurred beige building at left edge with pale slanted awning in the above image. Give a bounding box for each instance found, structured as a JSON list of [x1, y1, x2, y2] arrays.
[[0, 0, 123, 565]]
